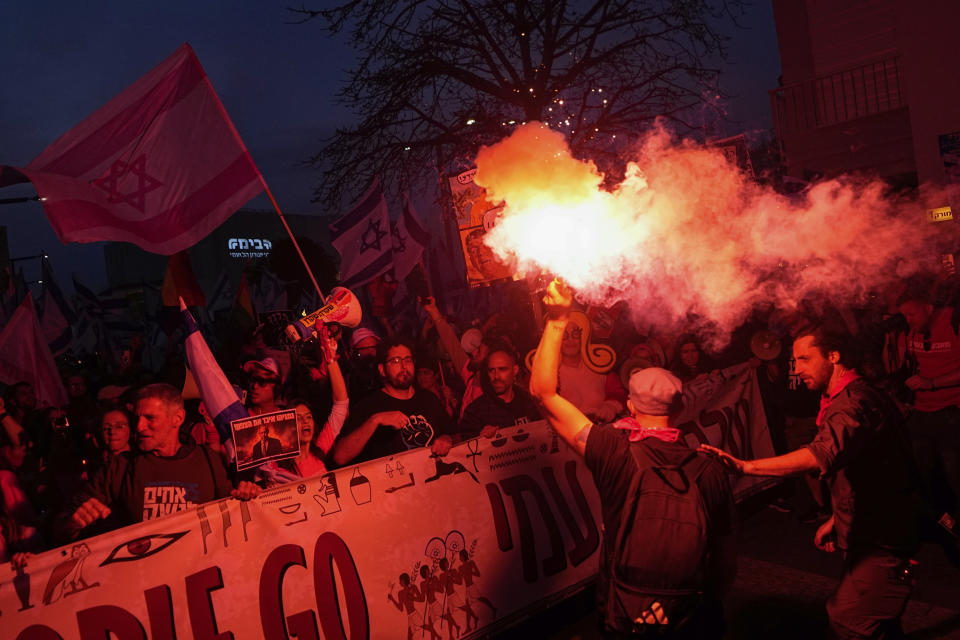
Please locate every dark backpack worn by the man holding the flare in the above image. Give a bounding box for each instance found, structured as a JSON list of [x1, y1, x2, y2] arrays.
[[601, 440, 710, 633]]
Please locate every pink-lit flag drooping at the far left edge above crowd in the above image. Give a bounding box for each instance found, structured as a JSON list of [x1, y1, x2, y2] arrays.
[[0, 293, 67, 407]]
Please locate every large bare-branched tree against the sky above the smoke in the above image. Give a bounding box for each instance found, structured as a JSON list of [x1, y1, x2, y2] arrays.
[[290, 0, 742, 206]]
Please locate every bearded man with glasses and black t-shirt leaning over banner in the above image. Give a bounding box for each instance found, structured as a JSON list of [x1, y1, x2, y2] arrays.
[[333, 338, 452, 466]]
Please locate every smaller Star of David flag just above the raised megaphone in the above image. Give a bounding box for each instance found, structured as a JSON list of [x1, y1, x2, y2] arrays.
[[330, 179, 393, 289]]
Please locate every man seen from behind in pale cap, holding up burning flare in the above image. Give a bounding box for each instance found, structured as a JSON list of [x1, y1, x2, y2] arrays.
[[530, 280, 736, 640]]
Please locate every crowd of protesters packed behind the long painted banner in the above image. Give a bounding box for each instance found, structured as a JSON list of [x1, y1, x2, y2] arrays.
[[0, 264, 960, 632]]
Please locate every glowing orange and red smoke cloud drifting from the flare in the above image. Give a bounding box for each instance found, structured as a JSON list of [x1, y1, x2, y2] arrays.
[[475, 122, 936, 342]]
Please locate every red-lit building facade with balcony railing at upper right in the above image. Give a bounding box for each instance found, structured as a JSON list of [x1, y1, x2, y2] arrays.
[[770, 0, 960, 200]]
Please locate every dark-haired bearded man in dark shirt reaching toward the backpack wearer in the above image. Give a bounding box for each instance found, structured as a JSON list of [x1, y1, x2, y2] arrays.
[[700, 327, 917, 638]]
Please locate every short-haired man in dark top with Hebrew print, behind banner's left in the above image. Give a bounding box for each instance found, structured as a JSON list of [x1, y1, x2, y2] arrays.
[[61, 384, 260, 539]]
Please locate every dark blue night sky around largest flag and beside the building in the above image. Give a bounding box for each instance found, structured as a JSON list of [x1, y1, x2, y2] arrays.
[[0, 0, 780, 292]]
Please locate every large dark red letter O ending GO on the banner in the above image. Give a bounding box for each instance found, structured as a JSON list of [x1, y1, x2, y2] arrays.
[[313, 531, 370, 640]]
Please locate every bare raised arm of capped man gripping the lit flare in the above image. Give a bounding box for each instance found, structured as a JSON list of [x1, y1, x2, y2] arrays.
[[530, 280, 593, 455]]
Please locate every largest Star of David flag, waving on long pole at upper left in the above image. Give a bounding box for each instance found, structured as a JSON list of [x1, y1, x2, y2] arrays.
[[0, 44, 263, 255]]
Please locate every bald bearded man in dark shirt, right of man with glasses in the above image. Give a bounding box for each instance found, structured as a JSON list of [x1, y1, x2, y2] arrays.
[[457, 346, 540, 440]]
